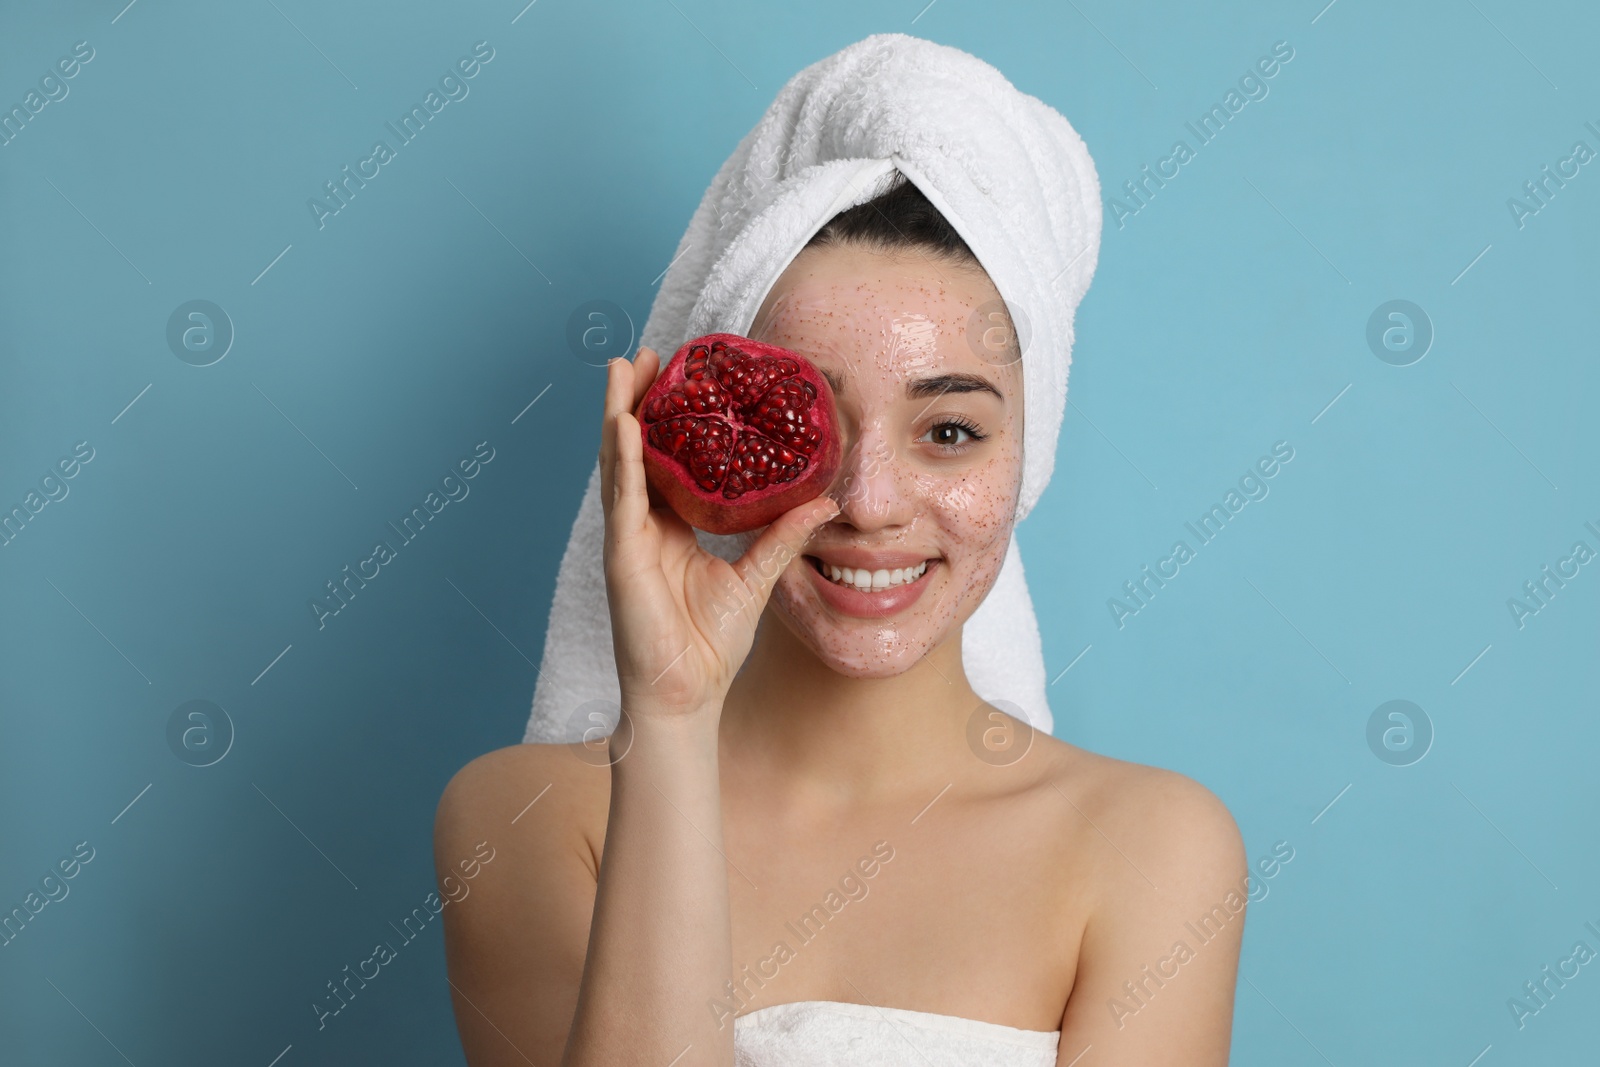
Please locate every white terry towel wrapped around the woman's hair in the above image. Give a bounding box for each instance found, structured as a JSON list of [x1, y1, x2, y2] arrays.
[[523, 34, 1101, 751]]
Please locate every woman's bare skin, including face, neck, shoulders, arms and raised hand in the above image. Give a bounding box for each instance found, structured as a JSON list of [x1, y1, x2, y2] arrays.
[[435, 246, 1246, 1067]]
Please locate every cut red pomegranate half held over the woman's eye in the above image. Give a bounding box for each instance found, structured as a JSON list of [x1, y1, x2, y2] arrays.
[[635, 333, 843, 534]]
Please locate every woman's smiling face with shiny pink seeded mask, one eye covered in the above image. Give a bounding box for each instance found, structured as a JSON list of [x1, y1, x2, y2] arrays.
[[752, 245, 1022, 677]]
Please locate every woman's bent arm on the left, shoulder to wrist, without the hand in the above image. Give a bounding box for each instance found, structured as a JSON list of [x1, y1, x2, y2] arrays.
[[434, 709, 733, 1067]]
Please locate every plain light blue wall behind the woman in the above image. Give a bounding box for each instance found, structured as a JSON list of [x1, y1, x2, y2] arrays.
[[0, 0, 1600, 1067]]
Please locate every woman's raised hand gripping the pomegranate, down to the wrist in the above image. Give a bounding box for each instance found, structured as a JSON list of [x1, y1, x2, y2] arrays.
[[600, 347, 838, 717]]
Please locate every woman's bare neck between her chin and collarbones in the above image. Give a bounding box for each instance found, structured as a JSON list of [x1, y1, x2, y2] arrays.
[[722, 611, 981, 803]]
